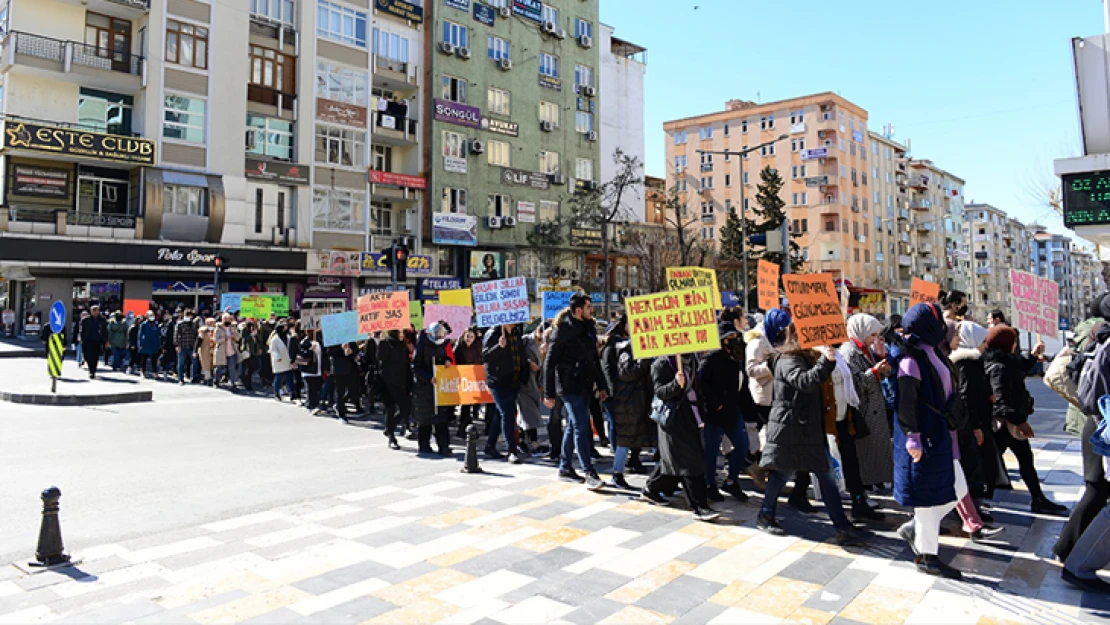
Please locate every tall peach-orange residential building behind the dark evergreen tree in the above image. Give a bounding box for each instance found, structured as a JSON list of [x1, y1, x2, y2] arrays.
[[664, 93, 872, 283]]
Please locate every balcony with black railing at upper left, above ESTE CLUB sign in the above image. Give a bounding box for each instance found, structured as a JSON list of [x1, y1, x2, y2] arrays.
[[0, 31, 147, 93]]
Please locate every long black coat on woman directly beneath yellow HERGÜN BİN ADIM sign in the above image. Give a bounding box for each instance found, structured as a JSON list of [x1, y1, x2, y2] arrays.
[[652, 355, 705, 477]]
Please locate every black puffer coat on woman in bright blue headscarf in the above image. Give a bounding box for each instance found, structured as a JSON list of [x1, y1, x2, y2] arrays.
[[760, 353, 836, 473]]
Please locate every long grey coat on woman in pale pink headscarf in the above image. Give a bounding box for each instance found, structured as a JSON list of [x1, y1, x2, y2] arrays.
[[840, 340, 895, 485]]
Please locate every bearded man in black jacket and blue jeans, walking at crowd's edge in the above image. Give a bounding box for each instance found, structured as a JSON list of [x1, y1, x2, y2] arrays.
[[544, 292, 609, 491]]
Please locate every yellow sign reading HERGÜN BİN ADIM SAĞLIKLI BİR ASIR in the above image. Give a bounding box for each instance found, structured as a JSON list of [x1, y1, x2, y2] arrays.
[[625, 289, 720, 359]]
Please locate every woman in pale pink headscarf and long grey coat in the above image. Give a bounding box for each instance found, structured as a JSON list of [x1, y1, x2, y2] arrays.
[[840, 314, 894, 518]]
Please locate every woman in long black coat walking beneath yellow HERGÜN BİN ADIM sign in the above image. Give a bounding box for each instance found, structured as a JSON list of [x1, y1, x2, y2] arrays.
[[642, 354, 720, 522]]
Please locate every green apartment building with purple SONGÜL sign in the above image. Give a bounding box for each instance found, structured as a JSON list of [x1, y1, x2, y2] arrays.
[[426, 0, 602, 280]]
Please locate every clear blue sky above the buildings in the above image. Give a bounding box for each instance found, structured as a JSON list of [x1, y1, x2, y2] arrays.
[[601, 0, 1103, 237]]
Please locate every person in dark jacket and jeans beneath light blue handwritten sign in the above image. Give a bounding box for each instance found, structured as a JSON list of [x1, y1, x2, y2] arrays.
[[482, 325, 532, 464]]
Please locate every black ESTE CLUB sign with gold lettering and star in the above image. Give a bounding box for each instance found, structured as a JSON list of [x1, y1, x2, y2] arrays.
[[3, 121, 154, 165]]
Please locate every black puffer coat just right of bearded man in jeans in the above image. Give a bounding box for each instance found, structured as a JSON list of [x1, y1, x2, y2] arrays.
[[602, 337, 655, 447]]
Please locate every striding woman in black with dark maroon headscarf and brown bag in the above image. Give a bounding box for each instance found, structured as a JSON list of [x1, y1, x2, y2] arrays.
[[982, 325, 1068, 515]]
